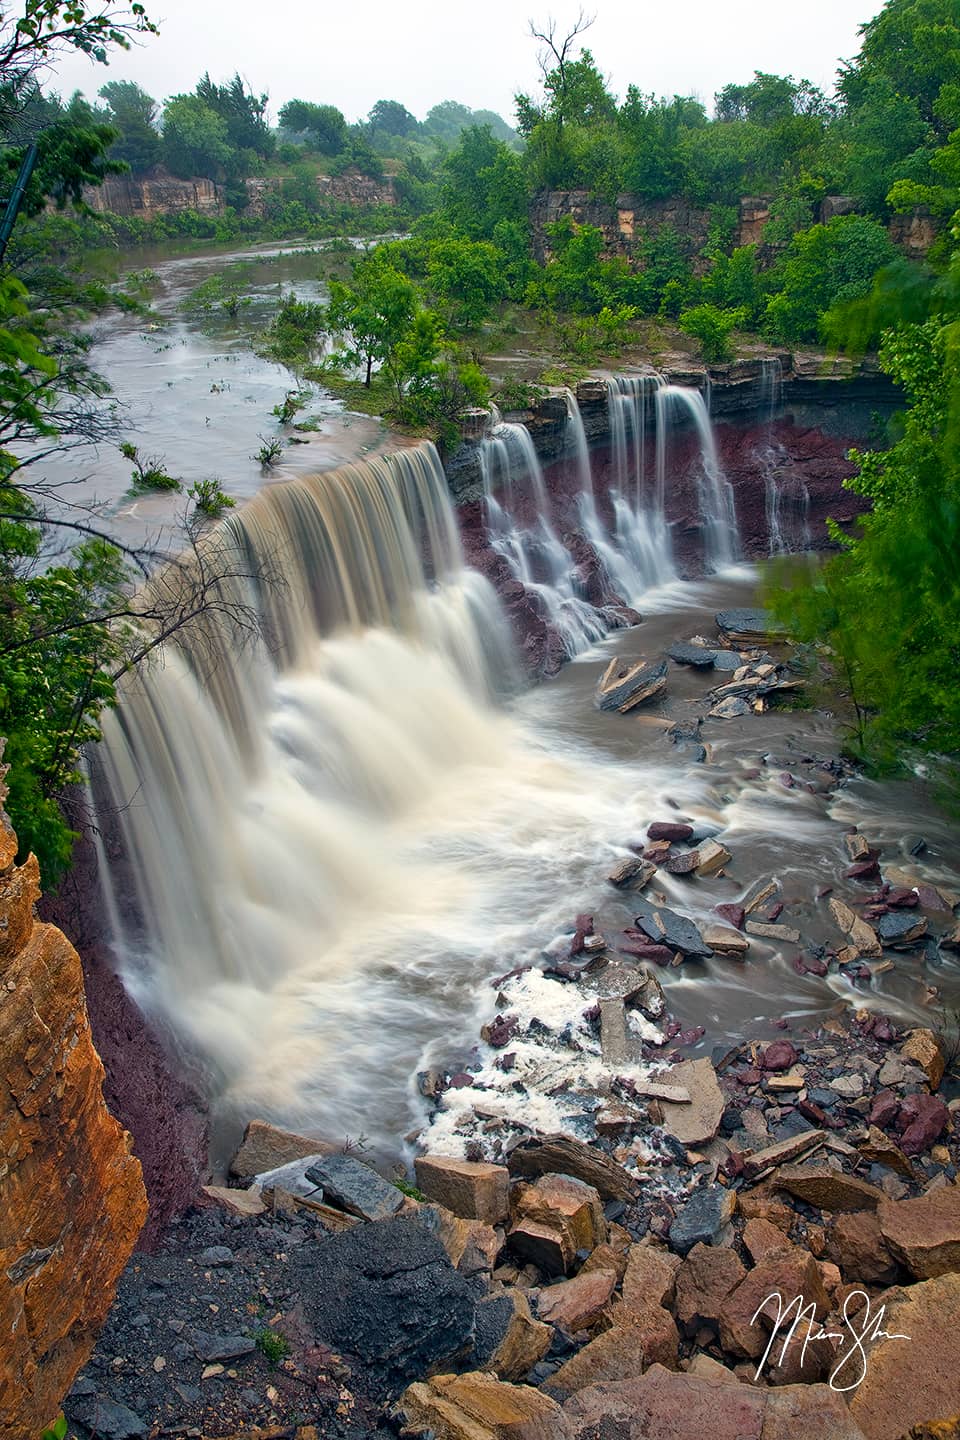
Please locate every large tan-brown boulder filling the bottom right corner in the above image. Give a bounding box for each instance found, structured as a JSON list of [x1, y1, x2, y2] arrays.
[[838, 1273, 960, 1440]]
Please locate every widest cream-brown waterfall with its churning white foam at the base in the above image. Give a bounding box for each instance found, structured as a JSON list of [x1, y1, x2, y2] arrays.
[[92, 446, 713, 1153]]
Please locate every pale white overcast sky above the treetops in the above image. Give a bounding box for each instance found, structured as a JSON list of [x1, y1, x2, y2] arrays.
[[48, 0, 881, 122]]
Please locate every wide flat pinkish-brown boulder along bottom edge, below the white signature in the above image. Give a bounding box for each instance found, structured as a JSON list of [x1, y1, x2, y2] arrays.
[[557, 1365, 872, 1440]]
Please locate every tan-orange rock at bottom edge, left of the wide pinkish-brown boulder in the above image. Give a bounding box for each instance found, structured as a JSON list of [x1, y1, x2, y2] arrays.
[[399, 1371, 563, 1440]]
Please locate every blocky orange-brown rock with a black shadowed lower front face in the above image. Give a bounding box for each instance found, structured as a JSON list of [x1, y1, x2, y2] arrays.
[[508, 1175, 607, 1274]]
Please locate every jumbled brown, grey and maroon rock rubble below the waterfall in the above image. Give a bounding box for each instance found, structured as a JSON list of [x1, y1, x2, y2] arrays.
[[58, 611, 960, 1440]]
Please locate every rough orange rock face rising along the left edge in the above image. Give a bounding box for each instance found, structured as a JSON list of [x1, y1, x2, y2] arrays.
[[0, 769, 147, 1440]]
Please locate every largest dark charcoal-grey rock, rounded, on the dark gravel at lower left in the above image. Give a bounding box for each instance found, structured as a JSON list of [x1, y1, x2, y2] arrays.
[[306, 1215, 476, 1395]]
